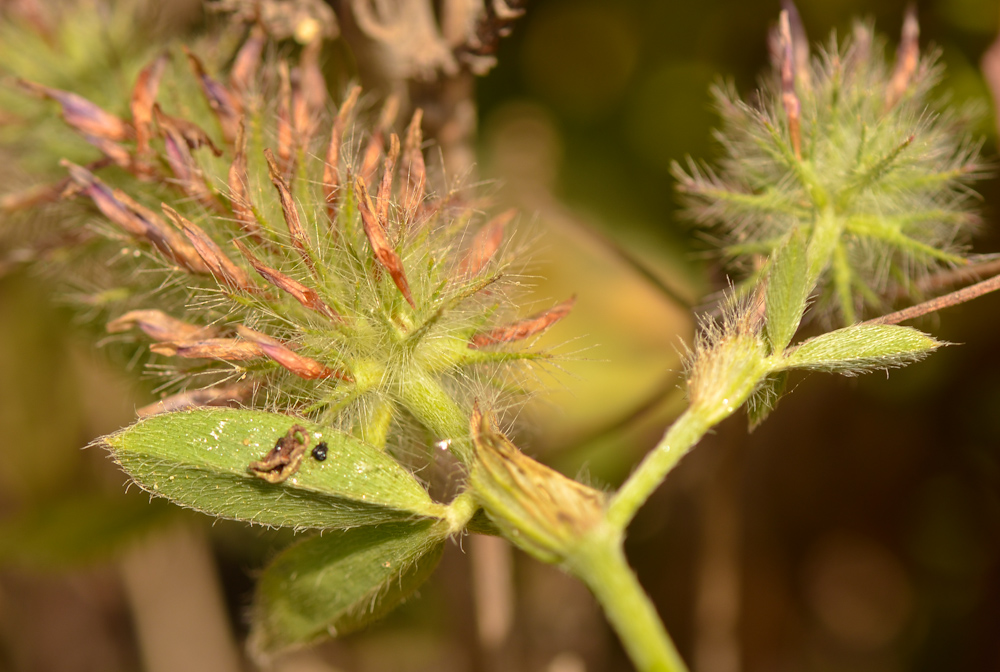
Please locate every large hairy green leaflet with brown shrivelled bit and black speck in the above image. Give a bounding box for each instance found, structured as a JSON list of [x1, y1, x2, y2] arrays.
[[102, 409, 444, 528]]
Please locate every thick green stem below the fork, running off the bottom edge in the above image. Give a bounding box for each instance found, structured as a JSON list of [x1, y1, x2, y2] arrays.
[[567, 527, 687, 672]]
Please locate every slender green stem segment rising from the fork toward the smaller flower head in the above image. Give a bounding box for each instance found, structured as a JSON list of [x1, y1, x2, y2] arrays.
[[605, 408, 712, 530]]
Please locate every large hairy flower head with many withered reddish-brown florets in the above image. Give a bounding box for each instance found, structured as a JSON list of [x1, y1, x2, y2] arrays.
[[11, 28, 572, 458]]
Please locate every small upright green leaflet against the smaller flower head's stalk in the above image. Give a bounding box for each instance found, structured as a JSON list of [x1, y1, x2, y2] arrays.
[[767, 229, 811, 354]]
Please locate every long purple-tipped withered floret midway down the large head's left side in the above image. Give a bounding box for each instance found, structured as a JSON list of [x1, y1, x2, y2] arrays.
[[61, 159, 209, 273]]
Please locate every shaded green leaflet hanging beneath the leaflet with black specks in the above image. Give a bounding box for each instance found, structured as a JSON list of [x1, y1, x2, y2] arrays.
[[250, 520, 447, 657]]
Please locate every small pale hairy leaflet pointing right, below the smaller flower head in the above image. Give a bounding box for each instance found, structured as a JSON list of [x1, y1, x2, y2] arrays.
[[774, 324, 944, 375]]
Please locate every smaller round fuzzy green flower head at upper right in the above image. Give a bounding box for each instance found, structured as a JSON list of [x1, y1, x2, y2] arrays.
[[674, 8, 981, 323]]
